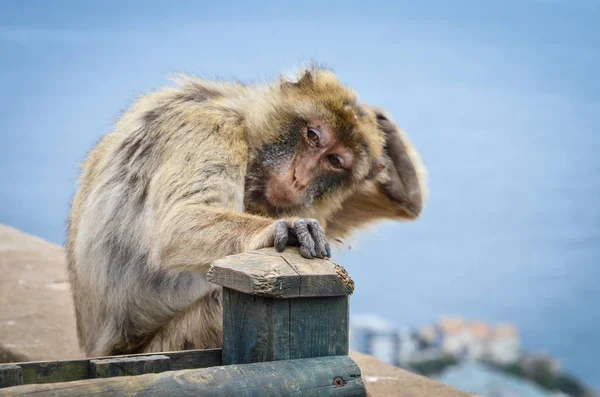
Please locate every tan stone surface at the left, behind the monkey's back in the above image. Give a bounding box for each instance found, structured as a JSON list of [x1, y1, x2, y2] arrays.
[[0, 225, 81, 361]]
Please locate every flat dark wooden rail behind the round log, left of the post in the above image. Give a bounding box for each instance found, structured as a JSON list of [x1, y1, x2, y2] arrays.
[[5, 349, 221, 387]]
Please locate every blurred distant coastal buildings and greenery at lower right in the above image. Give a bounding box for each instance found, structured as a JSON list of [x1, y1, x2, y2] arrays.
[[350, 315, 597, 397]]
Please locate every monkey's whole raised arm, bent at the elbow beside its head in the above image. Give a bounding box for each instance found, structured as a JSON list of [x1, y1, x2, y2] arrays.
[[327, 107, 427, 238]]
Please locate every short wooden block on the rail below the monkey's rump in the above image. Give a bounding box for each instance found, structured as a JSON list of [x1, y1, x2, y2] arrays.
[[90, 354, 171, 379]]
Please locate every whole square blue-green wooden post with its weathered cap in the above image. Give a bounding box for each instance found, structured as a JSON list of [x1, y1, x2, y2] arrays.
[[208, 247, 354, 365]]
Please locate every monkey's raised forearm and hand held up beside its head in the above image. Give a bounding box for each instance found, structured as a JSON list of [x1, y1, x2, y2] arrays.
[[371, 106, 423, 218]]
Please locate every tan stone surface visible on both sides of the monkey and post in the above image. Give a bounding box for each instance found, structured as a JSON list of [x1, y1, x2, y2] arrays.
[[0, 225, 468, 397]]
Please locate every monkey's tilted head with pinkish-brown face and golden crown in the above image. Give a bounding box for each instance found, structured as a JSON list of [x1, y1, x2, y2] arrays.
[[247, 67, 385, 213]]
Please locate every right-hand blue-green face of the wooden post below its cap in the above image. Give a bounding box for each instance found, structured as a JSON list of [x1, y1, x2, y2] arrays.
[[288, 296, 349, 358]]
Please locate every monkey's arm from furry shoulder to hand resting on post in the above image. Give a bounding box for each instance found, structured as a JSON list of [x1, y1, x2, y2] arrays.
[[149, 140, 331, 271]]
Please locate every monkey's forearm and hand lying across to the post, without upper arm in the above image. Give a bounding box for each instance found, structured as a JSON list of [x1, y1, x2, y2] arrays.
[[150, 202, 331, 272]]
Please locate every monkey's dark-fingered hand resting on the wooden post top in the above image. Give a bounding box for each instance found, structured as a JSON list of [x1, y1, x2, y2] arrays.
[[275, 218, 331, 259]]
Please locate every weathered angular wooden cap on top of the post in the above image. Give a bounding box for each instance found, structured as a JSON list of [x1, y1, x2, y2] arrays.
[[208, 247, 354, 298]]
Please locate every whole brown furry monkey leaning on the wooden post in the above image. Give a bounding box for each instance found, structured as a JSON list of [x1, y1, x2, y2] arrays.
[[66, 65, 427, 356]]
